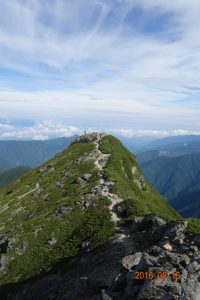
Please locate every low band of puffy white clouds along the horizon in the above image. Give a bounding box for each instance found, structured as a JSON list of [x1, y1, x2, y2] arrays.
[[0, 121, 200, 140]]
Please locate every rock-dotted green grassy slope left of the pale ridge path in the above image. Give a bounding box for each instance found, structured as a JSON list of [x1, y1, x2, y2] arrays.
[[0, 143, 114, 284]]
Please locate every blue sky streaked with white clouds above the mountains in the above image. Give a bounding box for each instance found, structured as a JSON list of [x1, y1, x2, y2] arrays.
[[0, 0, 200, 139]]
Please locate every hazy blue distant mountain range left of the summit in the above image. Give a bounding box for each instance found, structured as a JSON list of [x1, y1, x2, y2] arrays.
[[0, 136, 75, 171]]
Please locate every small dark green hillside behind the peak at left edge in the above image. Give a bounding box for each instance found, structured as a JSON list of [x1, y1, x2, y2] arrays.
[[0, 166, 32, 187]]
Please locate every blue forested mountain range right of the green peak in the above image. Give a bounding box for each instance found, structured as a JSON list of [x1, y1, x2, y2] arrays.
[[137, 136, 200, 217]]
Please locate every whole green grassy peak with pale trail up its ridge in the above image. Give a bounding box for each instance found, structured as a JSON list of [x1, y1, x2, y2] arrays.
[[0, 133, 179, 285]]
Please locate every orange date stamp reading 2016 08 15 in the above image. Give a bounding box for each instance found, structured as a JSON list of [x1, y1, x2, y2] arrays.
[[135, 271, 181, 281]]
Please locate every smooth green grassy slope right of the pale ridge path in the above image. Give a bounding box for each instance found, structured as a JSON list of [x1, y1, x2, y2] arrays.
[[101, 136, 179, 219]]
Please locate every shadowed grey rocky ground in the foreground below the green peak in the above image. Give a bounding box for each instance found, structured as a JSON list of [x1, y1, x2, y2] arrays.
[[6, 217, 200, 300]]
